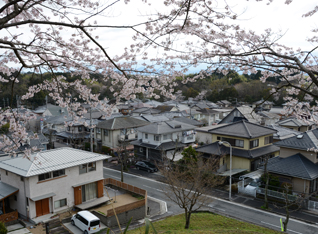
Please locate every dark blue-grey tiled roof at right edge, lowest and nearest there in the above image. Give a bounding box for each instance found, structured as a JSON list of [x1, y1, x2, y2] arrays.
[[267, 153, 318, 180]]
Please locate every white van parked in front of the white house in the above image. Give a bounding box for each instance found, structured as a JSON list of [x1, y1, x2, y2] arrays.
[[71, 210, 100, 234]]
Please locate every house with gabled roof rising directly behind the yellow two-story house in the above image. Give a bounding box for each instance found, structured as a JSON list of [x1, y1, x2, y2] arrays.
[[220, 106, 262, 124]]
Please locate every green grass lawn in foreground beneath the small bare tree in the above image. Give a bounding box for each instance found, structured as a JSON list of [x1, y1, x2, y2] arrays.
[[128, 213, 281, 234]]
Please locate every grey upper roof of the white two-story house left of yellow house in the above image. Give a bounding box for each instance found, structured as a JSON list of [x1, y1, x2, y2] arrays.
[[137, 120, 195, 134]]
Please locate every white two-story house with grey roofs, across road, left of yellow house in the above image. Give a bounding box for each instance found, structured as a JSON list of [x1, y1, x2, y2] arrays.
[[131, 120, 196, 161]]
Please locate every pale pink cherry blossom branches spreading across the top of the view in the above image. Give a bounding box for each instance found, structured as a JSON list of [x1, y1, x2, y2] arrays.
[[0, 0, 318, 155]]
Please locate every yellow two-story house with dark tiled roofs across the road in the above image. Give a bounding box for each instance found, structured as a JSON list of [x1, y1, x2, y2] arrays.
[[196, 120, 279, 172]]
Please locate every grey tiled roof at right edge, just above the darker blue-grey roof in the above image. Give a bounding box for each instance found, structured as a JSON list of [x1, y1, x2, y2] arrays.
[[275, 129, 318, 151]]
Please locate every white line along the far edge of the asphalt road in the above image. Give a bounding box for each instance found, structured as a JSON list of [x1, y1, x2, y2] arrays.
[[104, 167, 317, 228]]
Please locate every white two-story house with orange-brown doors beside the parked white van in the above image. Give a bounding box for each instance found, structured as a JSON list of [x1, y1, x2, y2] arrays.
[[0, 148, 110, 220]]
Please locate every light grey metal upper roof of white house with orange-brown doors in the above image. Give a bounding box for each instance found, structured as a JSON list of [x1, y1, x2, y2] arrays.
[[0, 147, 110, 177]]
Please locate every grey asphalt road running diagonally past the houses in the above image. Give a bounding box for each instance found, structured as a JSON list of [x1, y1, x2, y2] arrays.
[[104, 167, 318, 234]]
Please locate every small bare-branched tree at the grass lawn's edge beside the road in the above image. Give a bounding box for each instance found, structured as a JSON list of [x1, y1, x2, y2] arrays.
[[160, 147, 224, 229]]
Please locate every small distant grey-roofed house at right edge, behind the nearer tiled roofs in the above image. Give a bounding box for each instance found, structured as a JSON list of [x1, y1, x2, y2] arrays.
[[276, 117, 316, 132]]
